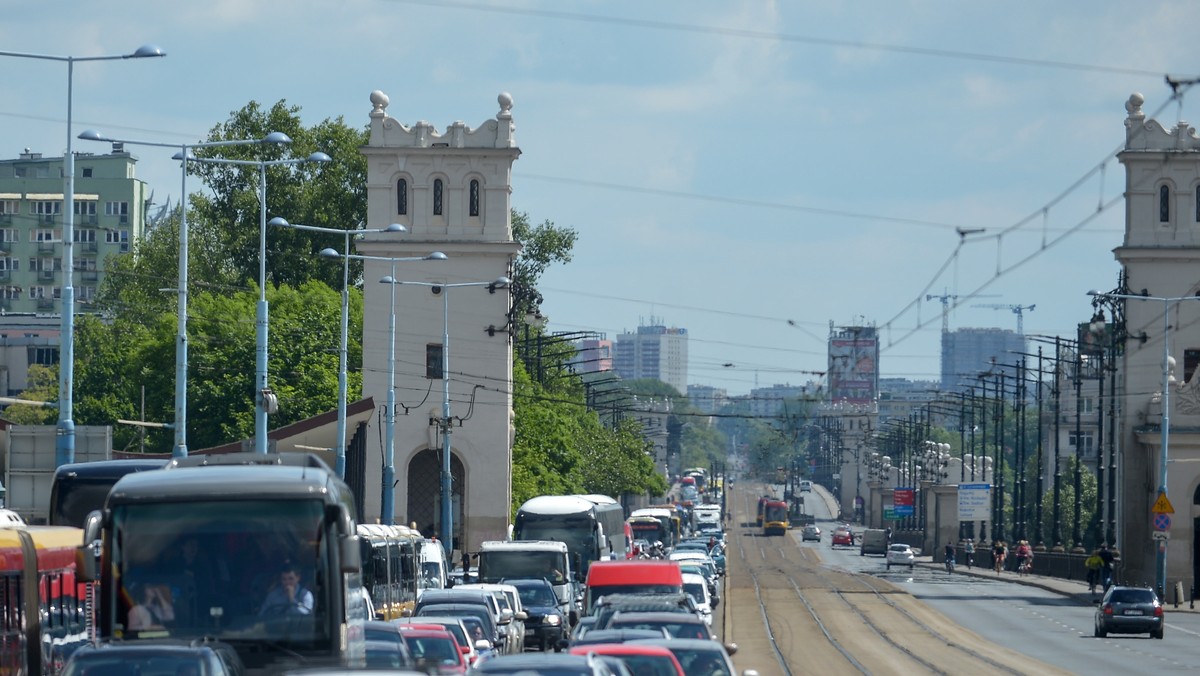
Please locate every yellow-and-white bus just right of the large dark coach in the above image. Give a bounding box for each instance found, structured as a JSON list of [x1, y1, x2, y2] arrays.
[[358, 524, 422, 621]]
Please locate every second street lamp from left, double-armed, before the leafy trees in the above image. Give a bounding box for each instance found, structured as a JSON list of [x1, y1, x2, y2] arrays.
[[79, 130, 292, 457]]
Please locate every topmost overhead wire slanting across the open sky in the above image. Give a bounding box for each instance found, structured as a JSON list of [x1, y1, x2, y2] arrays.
[[392, 0, 1163, 78]]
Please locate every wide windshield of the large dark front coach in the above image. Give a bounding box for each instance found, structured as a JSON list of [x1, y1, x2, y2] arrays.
[[104, 501, 334, 650]]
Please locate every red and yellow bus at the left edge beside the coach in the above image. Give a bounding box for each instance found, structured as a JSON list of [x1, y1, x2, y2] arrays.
[[0, 524, 90, 675]]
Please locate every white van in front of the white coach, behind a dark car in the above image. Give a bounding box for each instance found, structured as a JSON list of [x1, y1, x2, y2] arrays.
[[478, 540, 581, 626]]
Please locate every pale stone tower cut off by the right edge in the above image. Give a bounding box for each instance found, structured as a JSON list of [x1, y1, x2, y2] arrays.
[[1114, 94, 1200, 590]]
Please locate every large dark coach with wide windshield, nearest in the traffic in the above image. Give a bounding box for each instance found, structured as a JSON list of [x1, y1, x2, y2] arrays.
[[76, 453, 366, 674]]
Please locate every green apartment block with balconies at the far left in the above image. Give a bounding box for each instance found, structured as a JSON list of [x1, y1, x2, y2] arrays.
[[0, 144, 149, 315]]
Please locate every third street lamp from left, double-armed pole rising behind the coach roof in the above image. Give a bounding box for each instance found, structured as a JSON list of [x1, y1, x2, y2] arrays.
[[191, 151, 331, 454]]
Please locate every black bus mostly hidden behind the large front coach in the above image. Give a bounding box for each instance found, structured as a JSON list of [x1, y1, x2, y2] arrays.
[[49, 457, 167, 528]]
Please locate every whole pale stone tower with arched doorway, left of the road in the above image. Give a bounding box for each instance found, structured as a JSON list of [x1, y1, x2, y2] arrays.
[[356, 91, 521, 551]]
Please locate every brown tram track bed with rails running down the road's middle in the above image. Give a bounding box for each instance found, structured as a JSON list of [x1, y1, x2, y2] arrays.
[[728, 485, 1070, 676]]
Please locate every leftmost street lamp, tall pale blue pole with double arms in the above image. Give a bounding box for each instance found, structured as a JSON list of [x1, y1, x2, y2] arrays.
[[0, 44, 167, 467]]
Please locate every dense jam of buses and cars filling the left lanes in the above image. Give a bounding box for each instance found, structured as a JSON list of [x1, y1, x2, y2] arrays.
[[0, 454, 744, 676]]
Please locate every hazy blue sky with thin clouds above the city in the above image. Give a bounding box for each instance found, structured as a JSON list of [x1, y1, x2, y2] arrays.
[[0, 0, 1200, 395]]
